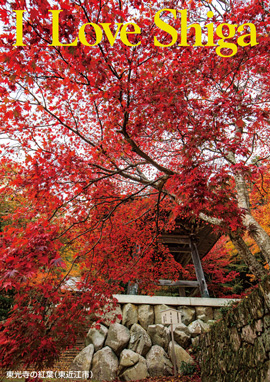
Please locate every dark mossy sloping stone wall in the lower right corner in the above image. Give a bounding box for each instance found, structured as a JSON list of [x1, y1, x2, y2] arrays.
[[198, 279, 270, 382]]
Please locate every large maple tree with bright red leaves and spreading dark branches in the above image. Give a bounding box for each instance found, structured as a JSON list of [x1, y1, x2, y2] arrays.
[[0, 0, 270, 372]]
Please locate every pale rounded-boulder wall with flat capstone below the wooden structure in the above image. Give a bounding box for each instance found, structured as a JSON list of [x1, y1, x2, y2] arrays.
[[70, 296, 234, 381]]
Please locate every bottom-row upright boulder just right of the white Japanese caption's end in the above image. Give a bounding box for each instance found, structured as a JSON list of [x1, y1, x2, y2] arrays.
[[91, 346, 118, 381]]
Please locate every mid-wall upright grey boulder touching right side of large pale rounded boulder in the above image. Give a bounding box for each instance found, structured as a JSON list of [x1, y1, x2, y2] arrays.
[[128, 324, 152, 356]]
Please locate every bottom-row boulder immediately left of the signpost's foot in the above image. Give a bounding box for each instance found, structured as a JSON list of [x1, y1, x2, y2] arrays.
[[146, 345, 173, 377]]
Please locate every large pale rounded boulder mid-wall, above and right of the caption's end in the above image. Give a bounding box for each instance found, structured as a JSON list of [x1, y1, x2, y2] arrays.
[[105, 323, 130, 355]]
